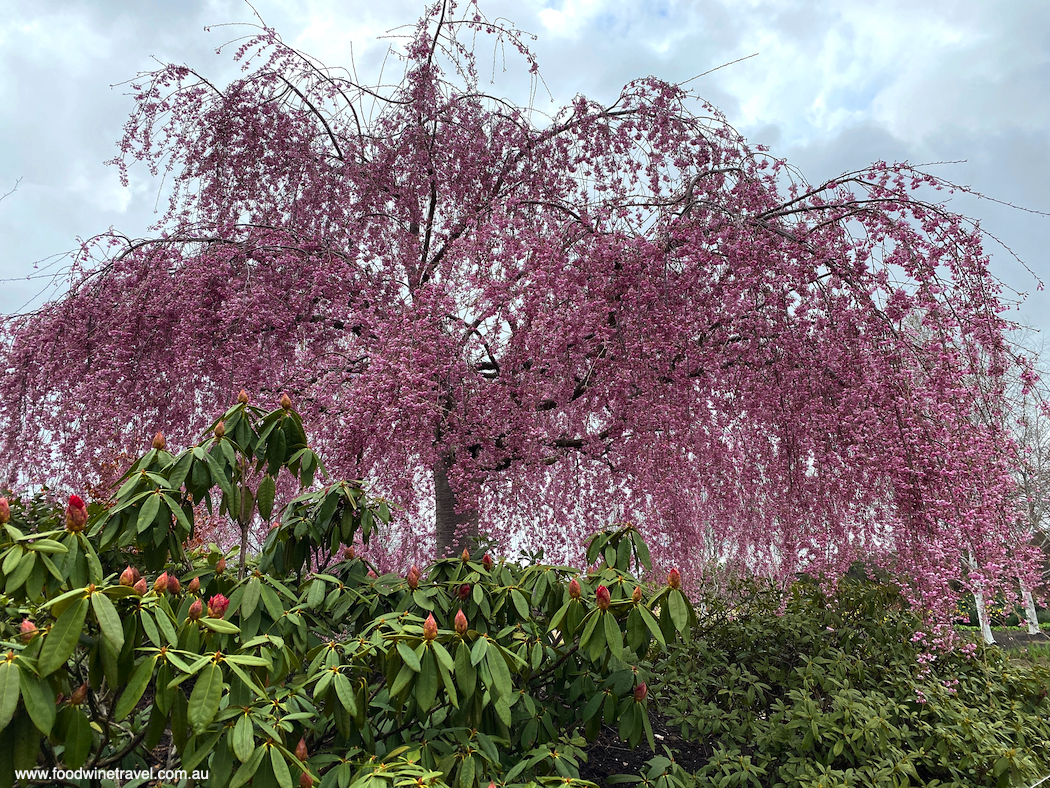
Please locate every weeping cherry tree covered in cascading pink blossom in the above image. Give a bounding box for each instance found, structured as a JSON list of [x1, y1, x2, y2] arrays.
[[0, 2, 1034, 604]]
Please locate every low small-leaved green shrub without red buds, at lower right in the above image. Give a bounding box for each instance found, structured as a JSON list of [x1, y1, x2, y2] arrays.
[[654, 580, 1050, 788]]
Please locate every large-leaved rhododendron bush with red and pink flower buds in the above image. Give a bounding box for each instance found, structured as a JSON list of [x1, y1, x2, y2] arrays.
[[0, 402, 695, 788]]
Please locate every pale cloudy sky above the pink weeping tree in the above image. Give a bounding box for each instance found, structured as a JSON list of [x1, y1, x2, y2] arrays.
[[0, 0, 1050, 344]]
